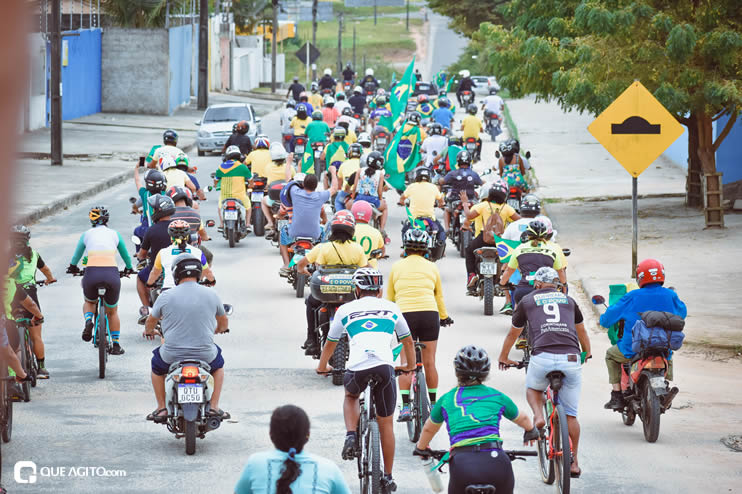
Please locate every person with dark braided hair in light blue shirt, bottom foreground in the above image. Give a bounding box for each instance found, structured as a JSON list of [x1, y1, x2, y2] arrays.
[[234, 405, 350, 494]]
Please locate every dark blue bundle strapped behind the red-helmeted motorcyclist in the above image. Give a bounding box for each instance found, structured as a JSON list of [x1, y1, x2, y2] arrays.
[[631, 310, 685, 353]]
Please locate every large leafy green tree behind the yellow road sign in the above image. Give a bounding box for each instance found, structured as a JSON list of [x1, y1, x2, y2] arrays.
[[468, 0, 742, 224]]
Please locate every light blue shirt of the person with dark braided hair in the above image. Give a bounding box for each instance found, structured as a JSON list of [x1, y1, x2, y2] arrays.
[[234, 449, 350, 494]]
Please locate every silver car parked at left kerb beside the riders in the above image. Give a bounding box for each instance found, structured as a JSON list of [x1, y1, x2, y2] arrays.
[[196, 103, 262, 156]]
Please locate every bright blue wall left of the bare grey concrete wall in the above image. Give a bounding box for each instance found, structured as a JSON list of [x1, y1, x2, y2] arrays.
[[46, 29, 101, 126]]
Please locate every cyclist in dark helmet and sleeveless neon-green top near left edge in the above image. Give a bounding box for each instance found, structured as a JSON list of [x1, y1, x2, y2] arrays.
[[10, 225, 57, 379]]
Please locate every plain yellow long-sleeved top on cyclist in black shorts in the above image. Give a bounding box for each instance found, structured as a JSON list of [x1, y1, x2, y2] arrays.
[[386, 255, 448, 319]]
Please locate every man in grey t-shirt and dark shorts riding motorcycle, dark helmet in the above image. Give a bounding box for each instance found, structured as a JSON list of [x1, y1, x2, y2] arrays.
[[143, 254, 230, 423]]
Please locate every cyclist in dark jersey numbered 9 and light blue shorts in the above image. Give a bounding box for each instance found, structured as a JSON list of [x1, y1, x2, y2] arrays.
[[499, 267, 591, 478]]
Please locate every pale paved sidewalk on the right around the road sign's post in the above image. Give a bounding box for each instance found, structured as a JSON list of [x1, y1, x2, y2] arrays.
[[507, 98, 742, 348]]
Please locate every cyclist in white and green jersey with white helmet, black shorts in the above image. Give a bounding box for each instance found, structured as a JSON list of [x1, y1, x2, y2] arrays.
[[317, 268, 415, 493]]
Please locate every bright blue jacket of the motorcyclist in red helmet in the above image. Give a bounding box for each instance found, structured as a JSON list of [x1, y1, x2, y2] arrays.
[[600, 283, 688, 358]]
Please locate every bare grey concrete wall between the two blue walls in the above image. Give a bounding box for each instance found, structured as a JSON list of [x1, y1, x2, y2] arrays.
[[101, 28, 170, 115]]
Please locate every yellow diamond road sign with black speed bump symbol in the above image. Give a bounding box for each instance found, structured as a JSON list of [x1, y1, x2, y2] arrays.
[[587, 81, 683, 177]]
